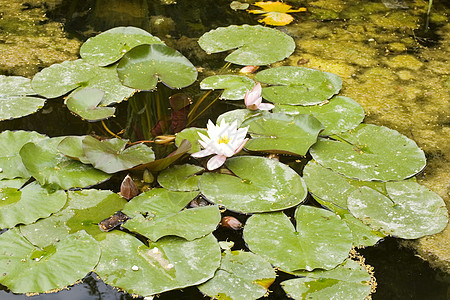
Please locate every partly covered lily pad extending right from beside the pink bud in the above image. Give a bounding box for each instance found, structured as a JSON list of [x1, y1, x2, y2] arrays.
[[274, 96, 364, 135]]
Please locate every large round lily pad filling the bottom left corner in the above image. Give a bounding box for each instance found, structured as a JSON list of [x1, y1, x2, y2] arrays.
[[0, 230, 100, 293]]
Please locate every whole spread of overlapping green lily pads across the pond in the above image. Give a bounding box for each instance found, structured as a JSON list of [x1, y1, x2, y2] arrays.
[[0, 25, 448, 299]]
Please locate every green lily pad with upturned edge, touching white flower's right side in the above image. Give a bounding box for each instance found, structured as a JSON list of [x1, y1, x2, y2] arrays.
[[241, 113, 323, 155]]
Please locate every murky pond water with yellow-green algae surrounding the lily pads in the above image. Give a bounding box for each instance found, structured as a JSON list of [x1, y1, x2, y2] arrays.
[[0, 0, 450, 300]]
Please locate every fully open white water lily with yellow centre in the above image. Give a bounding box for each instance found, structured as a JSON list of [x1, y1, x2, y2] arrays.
[[191, 120, 248, 170]]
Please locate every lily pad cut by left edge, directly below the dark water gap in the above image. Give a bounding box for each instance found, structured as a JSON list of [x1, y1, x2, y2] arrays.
[[0, 130, 47, 179]]
